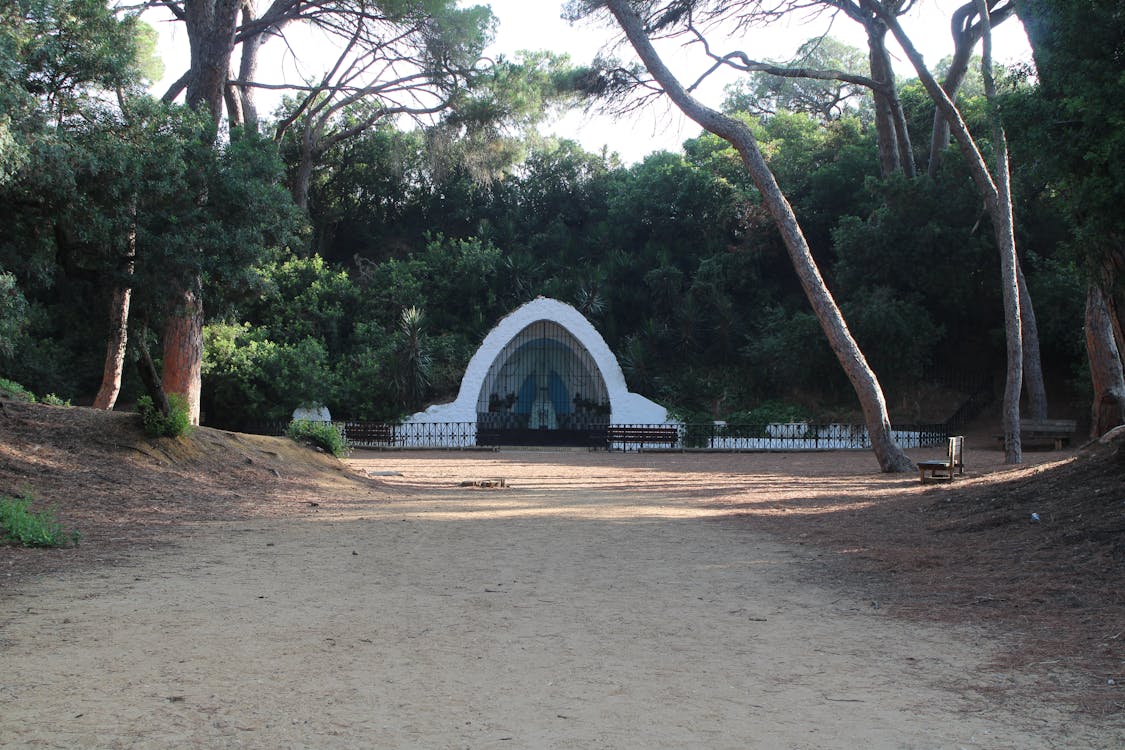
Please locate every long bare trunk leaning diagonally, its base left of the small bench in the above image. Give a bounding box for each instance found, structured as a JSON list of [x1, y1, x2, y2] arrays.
[[605, 0, 915, 472]]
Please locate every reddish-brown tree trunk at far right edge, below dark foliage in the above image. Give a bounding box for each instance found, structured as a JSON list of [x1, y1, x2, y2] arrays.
[[1086, 282, 1125, 437]]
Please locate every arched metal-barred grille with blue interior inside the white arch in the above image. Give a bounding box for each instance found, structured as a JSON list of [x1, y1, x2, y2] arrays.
[[477, 320, 610, 445]]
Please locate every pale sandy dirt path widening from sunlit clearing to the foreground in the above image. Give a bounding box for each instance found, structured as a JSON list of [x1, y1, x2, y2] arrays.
[[0, 453, 1125, 750]]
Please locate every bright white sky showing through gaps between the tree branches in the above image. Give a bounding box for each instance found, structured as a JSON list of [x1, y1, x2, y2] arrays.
[[153, 0, 1031, 163]]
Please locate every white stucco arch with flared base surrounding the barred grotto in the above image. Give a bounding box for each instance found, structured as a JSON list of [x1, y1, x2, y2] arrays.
[[407, 297, 668, 424]]
